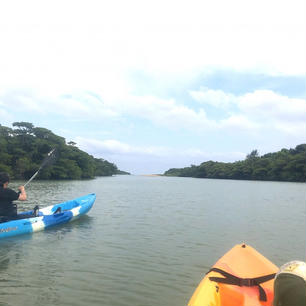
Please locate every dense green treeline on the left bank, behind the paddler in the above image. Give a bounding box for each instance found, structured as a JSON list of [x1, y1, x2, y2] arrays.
[[0, 122, 127, 179]]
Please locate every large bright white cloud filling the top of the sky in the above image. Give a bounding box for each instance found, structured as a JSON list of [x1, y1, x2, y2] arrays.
[[0, 0, 306, 97]]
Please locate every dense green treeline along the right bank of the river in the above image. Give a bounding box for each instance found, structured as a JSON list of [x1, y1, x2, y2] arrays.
[[164, 144, 306, 182]]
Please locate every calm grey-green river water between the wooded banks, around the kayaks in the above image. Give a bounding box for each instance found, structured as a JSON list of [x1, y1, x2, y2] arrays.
[[0, 176, 306, 306]]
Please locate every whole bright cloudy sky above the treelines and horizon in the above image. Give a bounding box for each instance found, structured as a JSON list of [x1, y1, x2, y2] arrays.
[[0, 0, 306, 174]]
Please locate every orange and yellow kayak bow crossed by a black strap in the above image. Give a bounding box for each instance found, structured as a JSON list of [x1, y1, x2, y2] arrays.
[[188, 244, 278, 306]]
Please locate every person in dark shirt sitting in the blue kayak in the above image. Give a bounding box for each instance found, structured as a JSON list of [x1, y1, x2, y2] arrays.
[[0, 172, 37, 222]]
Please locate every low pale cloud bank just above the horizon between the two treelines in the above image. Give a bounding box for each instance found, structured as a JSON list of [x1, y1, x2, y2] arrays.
[[74, 137, 245, 174]]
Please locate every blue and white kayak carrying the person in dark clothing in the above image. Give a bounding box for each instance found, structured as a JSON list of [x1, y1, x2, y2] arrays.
[[0, 193, 96, 239]]
